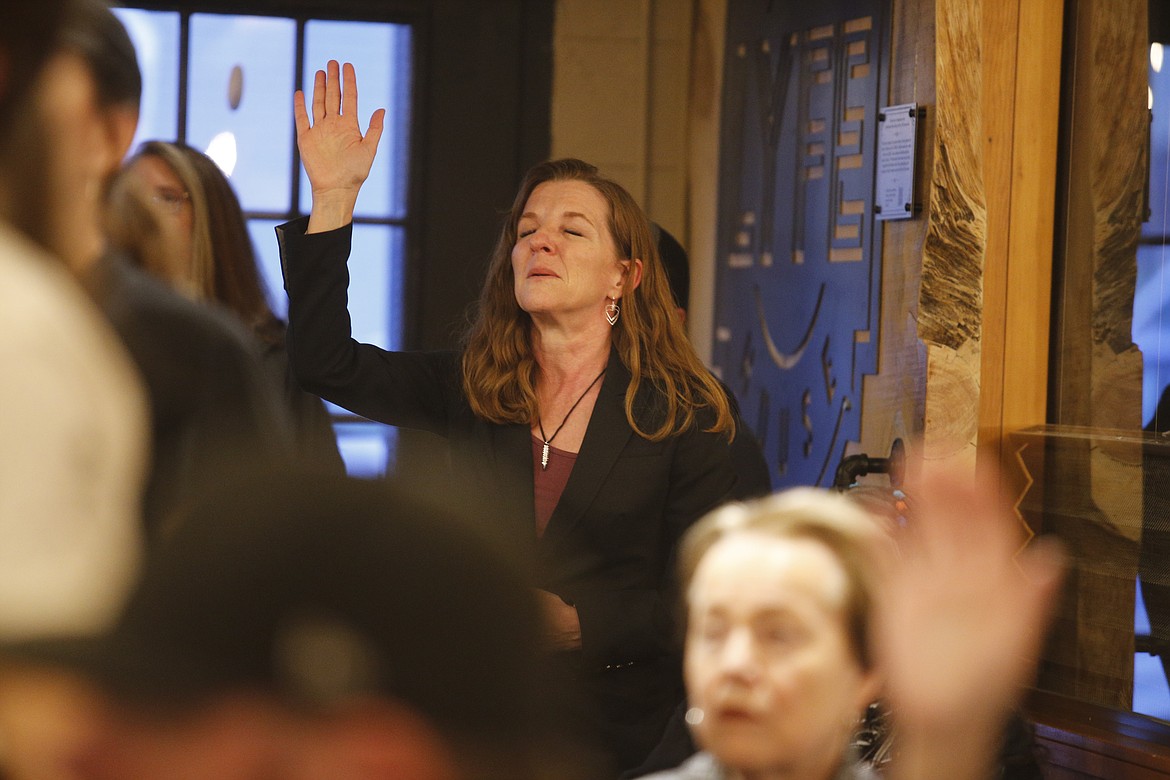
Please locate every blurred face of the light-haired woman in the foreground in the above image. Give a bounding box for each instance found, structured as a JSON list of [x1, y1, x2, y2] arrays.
[[686, 532, 876, 778]]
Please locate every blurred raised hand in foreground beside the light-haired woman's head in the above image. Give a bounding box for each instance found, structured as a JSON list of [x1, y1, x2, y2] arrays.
[[876, 463, 1062, 780]]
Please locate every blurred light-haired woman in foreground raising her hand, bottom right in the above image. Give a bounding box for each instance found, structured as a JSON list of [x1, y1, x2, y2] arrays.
[[648, 467, 1061, 780]]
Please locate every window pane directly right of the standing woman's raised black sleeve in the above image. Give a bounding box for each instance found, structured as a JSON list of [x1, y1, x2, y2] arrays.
[[350, 225, 404, 350]]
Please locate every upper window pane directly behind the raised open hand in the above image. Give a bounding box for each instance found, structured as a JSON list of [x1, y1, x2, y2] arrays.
[[301, 20, 411, 218]]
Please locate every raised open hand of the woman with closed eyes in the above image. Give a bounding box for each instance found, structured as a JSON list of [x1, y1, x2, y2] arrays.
[[293, 60, 386, 233]]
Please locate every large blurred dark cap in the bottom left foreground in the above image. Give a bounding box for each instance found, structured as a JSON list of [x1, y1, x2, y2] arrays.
[[8, 475, 541, 744]]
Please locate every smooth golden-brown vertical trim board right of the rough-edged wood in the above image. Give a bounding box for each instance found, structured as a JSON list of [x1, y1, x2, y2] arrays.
[[979, 0, 1064, 467]]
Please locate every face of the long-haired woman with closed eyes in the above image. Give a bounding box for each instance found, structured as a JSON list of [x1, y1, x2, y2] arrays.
[[511, 180, 629, 323]]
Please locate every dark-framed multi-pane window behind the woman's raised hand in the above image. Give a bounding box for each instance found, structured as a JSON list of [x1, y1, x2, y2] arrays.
[[115, 7, 413, 476]]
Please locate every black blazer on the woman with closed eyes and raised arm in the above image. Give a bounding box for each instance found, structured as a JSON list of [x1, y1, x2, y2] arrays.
[[277, 220, 758, 761]]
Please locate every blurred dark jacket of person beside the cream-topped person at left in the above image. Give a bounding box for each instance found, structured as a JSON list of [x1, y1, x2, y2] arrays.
[[89, 255, 293, 540]]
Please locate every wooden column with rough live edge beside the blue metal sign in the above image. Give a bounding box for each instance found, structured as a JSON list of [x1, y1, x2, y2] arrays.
[[861, 0, 1062, 468]]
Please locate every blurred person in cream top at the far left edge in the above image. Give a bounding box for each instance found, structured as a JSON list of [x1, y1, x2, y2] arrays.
[[0, 0, 147, 639]]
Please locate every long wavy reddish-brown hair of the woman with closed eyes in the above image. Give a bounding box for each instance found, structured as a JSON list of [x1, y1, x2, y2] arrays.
[[463, 159, 735, 441]]
